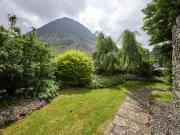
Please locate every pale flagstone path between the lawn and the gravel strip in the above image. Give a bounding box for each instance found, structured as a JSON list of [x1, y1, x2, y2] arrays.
[[104, 89, 151, 135]]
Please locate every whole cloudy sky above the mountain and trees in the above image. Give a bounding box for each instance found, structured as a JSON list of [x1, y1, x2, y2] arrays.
[[0, 0, 150, 47]]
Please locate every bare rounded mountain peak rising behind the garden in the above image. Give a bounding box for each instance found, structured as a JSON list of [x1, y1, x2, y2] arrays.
[[36, 17, 96, 54]]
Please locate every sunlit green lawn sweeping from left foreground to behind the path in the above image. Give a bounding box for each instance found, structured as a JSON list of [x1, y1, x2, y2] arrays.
[[1, 82, 172, 135]]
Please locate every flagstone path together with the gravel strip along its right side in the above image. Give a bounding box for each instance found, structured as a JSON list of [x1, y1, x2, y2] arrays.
[[104, 89, 180, 135]]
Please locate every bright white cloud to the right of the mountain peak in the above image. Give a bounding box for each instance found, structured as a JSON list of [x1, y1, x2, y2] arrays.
[[78, 0, 151, 48]]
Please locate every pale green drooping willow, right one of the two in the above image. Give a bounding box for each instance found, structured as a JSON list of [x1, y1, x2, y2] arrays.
[[119, 30, 142, 72]]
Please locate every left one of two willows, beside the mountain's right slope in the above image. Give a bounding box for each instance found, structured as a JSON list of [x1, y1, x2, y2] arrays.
[[93, 32, 118, 73]]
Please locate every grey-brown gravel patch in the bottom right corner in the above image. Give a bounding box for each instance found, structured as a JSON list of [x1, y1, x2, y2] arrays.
[[150, 98, 180, 135]]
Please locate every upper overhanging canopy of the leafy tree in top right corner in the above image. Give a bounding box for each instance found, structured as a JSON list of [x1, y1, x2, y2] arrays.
[[142, 0, 180, 44]]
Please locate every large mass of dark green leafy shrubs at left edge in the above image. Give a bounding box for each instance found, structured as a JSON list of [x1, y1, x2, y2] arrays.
[[0, 15, 52, 94]]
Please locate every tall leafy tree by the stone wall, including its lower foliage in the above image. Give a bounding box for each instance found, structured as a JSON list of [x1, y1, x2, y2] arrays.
[[142, 0, 180, 78]]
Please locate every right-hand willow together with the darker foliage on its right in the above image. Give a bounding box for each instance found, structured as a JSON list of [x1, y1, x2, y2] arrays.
[[119, 30, 153, 77]]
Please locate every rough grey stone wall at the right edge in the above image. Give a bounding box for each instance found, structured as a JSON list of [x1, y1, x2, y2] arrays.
[[172, 16, 180, 98]]
